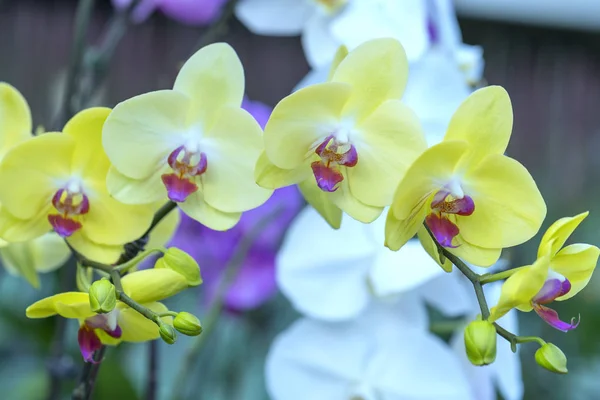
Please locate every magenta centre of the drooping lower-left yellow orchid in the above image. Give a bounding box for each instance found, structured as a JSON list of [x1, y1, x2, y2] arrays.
[[77, 310, 122, 363]]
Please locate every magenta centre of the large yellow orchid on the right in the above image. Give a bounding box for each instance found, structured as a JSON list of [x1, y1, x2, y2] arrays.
[[425, 185, 475, 248]]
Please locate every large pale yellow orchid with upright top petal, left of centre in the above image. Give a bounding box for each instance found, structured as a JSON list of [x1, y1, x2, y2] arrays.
[[102, 43, 272, 230]]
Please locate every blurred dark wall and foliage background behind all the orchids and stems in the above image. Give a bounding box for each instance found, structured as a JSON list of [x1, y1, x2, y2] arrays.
[[0, 0, 600, 400]]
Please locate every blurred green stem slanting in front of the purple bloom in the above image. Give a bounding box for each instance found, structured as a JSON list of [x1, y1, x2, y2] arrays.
[[172, 207, 283, 400]]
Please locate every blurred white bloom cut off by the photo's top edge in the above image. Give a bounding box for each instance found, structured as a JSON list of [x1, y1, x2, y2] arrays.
[[236, 0, 429, 68]]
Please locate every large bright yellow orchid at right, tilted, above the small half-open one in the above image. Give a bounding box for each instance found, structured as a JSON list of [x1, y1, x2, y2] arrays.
[[386, 86, 546, 266]]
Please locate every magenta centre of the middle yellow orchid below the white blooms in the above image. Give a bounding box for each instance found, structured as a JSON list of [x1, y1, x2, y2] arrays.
[[310, 135, 358, 192]]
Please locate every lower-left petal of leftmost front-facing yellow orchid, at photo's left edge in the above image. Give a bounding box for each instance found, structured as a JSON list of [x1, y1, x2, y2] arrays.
[[0, 203, 52, 242]]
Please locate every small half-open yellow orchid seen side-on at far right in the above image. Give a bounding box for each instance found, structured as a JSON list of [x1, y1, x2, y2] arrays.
[[490, 212, 600, 332]]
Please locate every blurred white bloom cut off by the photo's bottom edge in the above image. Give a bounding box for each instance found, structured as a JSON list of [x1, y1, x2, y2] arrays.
[[266, 299, 475, 400]]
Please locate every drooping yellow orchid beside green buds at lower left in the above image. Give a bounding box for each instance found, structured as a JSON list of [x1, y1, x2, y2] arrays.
[[26, 268, 188, 361]]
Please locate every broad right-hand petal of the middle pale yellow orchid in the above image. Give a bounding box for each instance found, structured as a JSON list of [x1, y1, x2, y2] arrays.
[[347, 100, 427, 207]]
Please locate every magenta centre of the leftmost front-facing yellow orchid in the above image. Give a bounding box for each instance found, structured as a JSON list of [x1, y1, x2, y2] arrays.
[[48, 182, 90, 237]]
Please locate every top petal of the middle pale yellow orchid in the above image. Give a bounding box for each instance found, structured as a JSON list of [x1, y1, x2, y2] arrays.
[[332, 38, 408, 121]]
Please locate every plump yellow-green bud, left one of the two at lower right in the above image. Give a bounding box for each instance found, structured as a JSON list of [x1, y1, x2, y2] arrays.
[[465, 321, 496, 365]]
